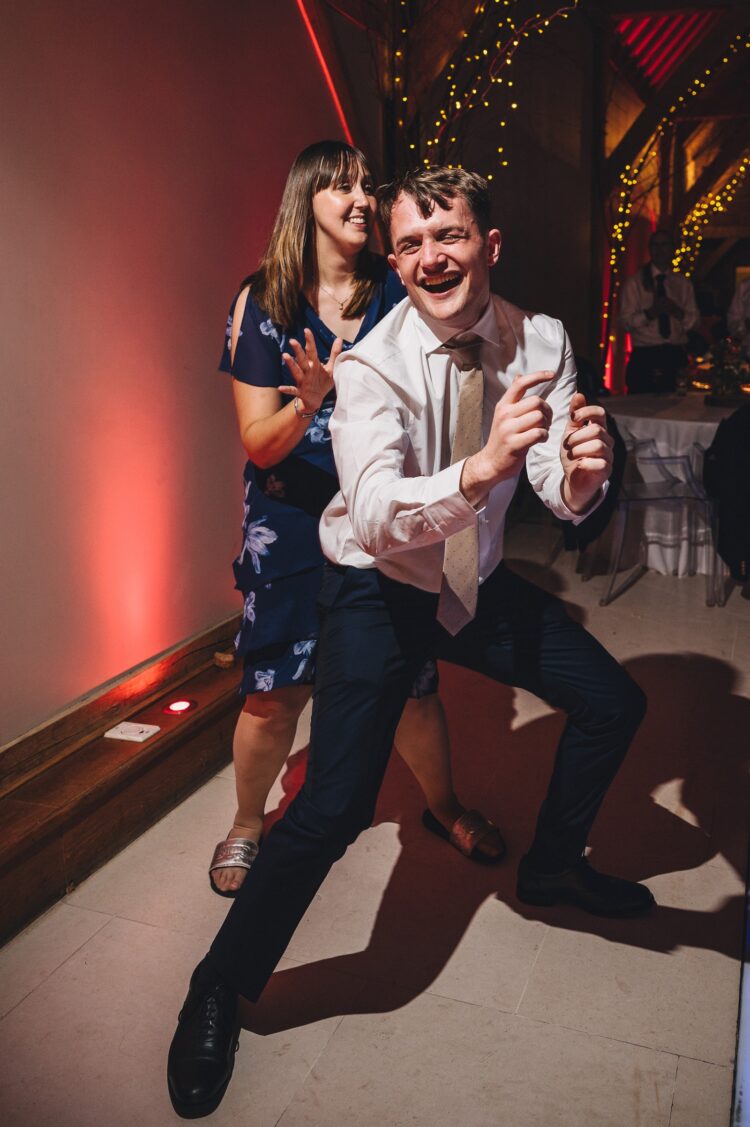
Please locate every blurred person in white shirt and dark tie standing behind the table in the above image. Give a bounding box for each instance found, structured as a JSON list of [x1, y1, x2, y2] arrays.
[[619, 230, 700, 394]]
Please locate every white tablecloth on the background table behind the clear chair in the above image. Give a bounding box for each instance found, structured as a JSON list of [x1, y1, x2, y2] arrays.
[[602, 392, 733, 575]]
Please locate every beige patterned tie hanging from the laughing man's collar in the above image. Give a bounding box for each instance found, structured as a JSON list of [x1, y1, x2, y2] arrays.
[[438, 334, 484, 635]]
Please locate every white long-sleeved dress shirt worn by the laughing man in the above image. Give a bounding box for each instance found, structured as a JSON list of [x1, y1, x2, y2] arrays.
[[320, 296, 603, 592]]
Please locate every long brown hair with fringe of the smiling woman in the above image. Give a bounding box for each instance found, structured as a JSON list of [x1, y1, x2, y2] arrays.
[[247, 141, 378, 329]]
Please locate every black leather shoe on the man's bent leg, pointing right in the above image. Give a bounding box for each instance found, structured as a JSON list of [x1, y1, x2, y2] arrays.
[[515, 858, 656, 916]]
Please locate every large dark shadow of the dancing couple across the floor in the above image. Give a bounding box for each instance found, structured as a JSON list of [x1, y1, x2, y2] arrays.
[[246, 655, 750, 1033]]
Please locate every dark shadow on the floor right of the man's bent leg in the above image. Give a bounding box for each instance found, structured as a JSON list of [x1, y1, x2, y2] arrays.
[[505, 654, 750, 959]]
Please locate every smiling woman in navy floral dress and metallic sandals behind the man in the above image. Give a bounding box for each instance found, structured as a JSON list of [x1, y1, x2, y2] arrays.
[[210, 141, 505, 896]]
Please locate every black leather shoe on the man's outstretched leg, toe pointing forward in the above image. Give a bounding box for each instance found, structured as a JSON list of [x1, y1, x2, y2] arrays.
[[167, 962, 239, 1119]]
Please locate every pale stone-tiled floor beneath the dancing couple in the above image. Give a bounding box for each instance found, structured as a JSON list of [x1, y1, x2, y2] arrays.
[[0, 525, 750, 1127]]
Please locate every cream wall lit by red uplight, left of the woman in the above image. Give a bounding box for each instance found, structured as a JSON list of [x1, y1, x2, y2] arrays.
[[0, 0, 341, 743]]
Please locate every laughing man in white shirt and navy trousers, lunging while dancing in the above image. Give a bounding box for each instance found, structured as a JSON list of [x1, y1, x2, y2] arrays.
[[168, 168, 654, 1118]]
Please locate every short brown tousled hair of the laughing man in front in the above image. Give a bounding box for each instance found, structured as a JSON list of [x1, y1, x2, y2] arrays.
[[378, 167, 492, 243]]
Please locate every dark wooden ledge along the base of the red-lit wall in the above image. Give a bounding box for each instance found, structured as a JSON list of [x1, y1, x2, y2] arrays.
[[0, 620, 240, 943]]
